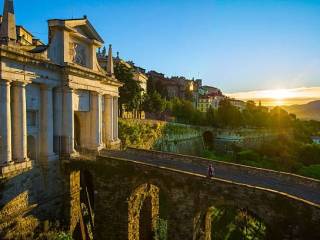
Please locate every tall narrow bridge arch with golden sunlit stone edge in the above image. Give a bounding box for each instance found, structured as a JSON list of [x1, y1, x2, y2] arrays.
[[128, 183, 159, 240]]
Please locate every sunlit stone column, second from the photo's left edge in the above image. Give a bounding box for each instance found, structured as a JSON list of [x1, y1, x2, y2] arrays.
[[12, 82, 28, 162]]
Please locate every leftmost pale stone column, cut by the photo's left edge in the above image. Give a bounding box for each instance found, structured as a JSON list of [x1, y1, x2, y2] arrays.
[[0, 80, 12, 165]]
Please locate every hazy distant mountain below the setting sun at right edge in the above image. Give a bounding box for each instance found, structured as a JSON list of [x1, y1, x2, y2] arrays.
[[283, 100, 320, 121]]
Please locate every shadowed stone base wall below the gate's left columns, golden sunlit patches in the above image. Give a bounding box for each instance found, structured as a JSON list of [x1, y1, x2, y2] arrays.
[[0, 161, 68, 239]]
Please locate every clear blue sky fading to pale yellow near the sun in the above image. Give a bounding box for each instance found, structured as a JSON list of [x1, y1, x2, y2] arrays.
[[8, 0, 320, 104]]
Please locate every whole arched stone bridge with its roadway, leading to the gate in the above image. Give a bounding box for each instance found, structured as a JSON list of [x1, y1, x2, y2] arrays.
[[66, 149, 320, 240]]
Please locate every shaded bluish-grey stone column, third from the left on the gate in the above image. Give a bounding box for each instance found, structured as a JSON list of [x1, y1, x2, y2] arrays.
[[40, 85, 54, 160]]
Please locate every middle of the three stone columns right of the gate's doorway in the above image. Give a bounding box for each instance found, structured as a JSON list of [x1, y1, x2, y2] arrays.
[[104, 95, 113, 145]]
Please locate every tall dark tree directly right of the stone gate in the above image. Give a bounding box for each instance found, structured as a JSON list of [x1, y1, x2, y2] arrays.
[[114, 63, 143, 114]]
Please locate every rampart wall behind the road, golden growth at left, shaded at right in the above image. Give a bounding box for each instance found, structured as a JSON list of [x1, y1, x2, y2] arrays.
[[119, 119, 204, 155]]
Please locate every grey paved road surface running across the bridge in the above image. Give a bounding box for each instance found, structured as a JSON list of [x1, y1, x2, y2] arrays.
[[103, 151, 320, 205]]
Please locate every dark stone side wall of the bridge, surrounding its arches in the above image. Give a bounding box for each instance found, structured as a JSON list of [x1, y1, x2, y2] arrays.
[[70, 156, 320, 240]]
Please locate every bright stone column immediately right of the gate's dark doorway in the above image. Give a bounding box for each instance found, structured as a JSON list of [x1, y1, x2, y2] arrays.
[[90, 92, 102, 150]]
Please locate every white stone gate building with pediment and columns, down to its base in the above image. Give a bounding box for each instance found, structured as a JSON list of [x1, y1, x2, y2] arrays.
[[0, 0, 122, 236]]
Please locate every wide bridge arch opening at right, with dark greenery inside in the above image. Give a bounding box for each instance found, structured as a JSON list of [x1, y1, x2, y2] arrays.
[[204, 206, 266, 240]]
